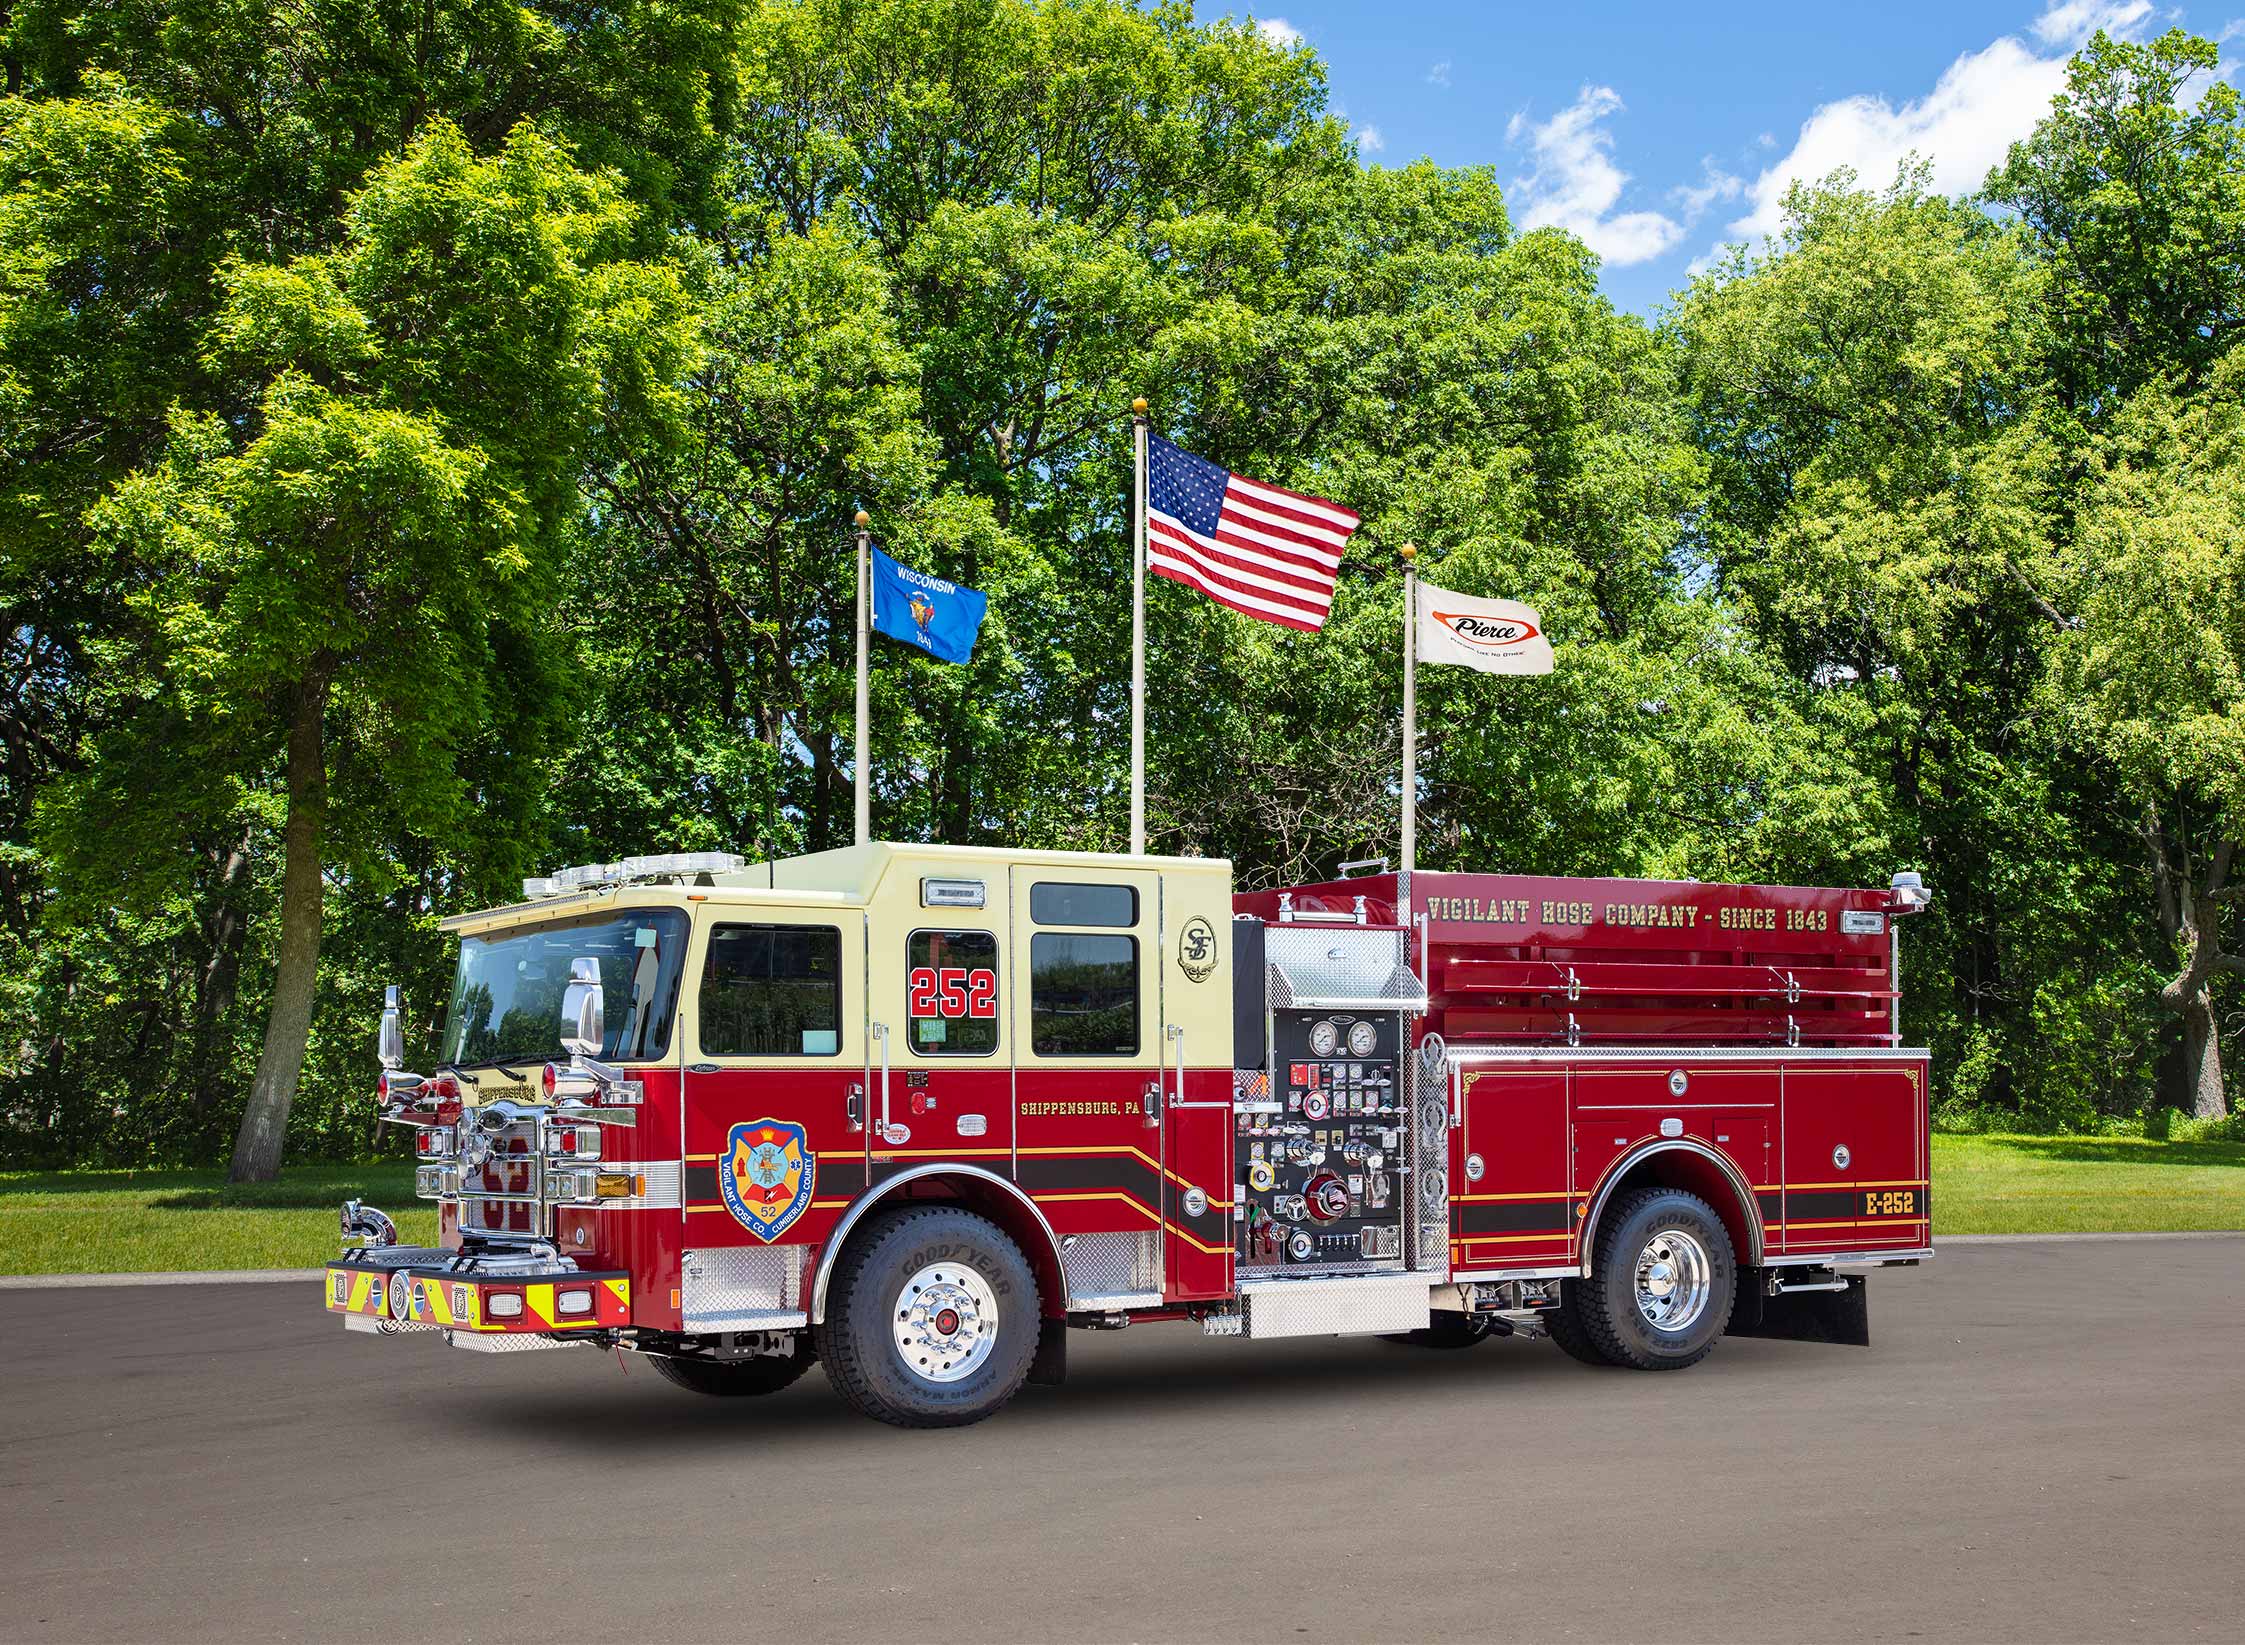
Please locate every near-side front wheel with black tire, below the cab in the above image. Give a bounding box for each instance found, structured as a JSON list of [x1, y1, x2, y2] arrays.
[[817, 1205, 1042, 1427]]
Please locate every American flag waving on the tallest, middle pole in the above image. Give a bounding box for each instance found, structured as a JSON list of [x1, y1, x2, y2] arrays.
[[1145, 435, 1356, 633]]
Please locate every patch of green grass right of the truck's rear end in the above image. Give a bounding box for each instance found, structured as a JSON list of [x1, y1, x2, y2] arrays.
[[1933, 1136, 2245, 1239]]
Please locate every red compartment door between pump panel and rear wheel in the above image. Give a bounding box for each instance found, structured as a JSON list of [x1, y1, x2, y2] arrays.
[[1450, 1064, 1574, 1275]]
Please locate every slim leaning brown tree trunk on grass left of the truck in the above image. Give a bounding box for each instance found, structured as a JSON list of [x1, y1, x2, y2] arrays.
[[227, 676, 328, 1183]]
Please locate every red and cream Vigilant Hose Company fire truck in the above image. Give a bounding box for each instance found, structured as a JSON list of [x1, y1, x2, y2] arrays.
[[326, 844, 1931, 1425]]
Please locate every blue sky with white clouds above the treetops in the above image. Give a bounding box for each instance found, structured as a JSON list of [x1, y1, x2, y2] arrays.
[[1248, 0, 2245, 314]]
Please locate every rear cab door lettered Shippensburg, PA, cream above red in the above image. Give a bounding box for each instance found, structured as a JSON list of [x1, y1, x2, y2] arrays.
[[1008, 864, 1170, 1306]]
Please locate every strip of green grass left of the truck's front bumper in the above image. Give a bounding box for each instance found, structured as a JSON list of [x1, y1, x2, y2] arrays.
[[0, 1165, 436, 1275]]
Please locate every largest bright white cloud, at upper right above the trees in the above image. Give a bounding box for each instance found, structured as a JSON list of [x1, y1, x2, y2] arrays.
[[1729, 0, 2151, 240]]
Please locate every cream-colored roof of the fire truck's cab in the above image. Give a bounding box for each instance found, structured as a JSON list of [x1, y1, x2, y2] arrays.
[[440, 839, 1233, 934]]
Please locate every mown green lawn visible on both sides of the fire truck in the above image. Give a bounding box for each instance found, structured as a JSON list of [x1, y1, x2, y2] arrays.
[[0, 1136, 2245, 1275]]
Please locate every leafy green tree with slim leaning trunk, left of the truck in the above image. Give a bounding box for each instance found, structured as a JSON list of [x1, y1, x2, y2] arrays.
[[52, 121, 676, 1178]]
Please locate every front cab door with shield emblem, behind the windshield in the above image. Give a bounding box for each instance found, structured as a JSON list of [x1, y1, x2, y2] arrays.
[[682, 904, 869, 1292]]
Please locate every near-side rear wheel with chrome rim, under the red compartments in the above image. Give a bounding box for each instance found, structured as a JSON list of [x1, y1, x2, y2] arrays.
[[1578, 1187, 1738, 1371]]
